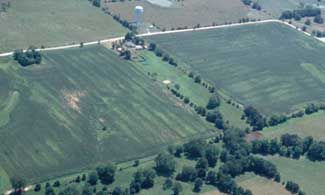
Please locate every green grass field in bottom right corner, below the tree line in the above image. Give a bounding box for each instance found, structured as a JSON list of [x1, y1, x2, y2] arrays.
[[266, 156, 325, 194]]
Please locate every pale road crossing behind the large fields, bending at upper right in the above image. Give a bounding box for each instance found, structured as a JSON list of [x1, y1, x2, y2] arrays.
[[0, 19, 325, 57]]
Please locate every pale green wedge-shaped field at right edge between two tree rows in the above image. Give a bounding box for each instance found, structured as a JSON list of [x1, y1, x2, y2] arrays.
[[261, 111, 325, 140]]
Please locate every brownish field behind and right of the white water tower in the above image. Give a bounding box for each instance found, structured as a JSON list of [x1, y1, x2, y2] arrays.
[[107, 0, 249, 29]]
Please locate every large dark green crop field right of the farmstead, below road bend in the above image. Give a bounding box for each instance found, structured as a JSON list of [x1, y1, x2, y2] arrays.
[[147, 22, 325, 115]]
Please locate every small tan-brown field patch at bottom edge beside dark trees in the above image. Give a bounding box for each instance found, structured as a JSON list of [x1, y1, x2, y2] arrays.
[[236, 173, 290, 195]]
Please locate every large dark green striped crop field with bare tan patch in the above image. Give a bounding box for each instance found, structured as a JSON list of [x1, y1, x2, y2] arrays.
[[0, 46, 214, 182]]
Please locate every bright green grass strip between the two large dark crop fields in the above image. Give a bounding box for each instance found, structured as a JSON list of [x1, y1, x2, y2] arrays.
[[132, 51, 247, 128]]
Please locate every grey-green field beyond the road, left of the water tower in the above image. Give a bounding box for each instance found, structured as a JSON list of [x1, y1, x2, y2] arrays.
[[0, 0, 126, 52]]
